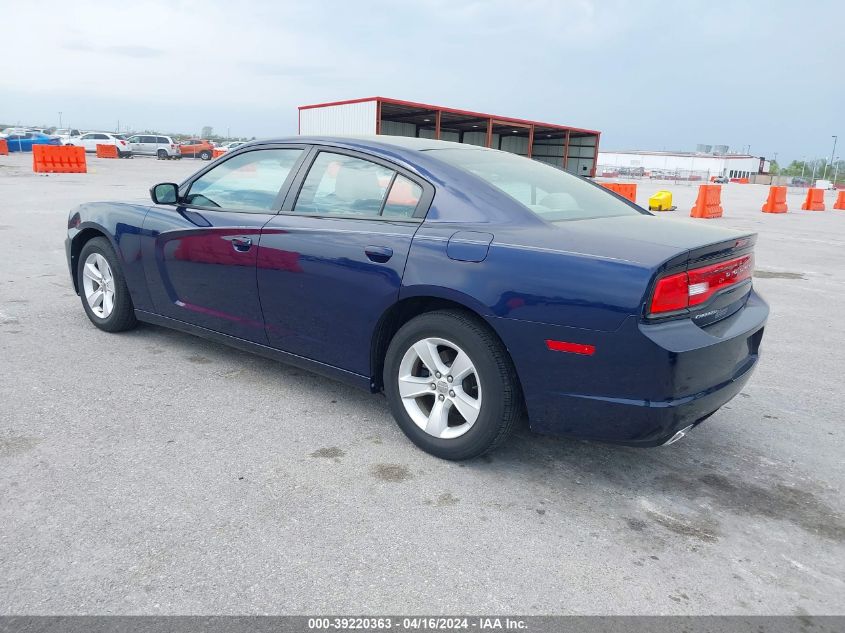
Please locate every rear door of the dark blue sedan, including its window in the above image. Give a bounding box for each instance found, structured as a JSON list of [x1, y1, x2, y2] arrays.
[[258, 148, 434, 375]]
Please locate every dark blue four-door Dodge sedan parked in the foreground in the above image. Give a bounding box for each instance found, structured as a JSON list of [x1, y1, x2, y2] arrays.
[[66, 137, 768, 459]]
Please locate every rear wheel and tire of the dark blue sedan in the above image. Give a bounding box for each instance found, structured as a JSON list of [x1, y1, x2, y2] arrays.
[[384, 310, 522, 460]]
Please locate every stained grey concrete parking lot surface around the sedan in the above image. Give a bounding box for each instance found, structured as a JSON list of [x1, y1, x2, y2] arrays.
[[0, 154, 845, 615]]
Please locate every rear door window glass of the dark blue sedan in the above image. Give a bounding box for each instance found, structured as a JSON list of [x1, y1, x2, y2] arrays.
[[293, 152, 395, 216]]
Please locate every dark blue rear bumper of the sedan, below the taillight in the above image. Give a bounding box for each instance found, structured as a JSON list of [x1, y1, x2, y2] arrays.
[[493, 291, 769, 446]]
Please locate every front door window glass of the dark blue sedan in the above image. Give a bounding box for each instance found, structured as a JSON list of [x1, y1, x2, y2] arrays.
[[184, 148, 302, 213]]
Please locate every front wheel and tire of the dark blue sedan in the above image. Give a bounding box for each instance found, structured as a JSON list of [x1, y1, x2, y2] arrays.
[[76, 237, 138, 332]]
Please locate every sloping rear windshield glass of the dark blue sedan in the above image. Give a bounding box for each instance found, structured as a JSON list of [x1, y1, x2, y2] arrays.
[[428, 149, 639, 222]]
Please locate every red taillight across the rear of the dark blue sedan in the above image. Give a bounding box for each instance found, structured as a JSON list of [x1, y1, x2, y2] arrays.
[[649, 254, 754, 314]]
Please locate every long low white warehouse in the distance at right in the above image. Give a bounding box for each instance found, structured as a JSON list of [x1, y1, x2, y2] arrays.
[[598, 151, 769, 180]]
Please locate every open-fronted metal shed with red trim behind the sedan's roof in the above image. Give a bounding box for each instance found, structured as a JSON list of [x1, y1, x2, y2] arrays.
[[299, 97, 601, 176]]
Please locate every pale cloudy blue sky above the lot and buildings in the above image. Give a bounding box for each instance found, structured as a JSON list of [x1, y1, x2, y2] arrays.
[[0, 0, 845, 164]]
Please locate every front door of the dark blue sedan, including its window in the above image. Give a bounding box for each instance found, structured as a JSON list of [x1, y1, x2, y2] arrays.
[[143, 146, 304, 344]]
